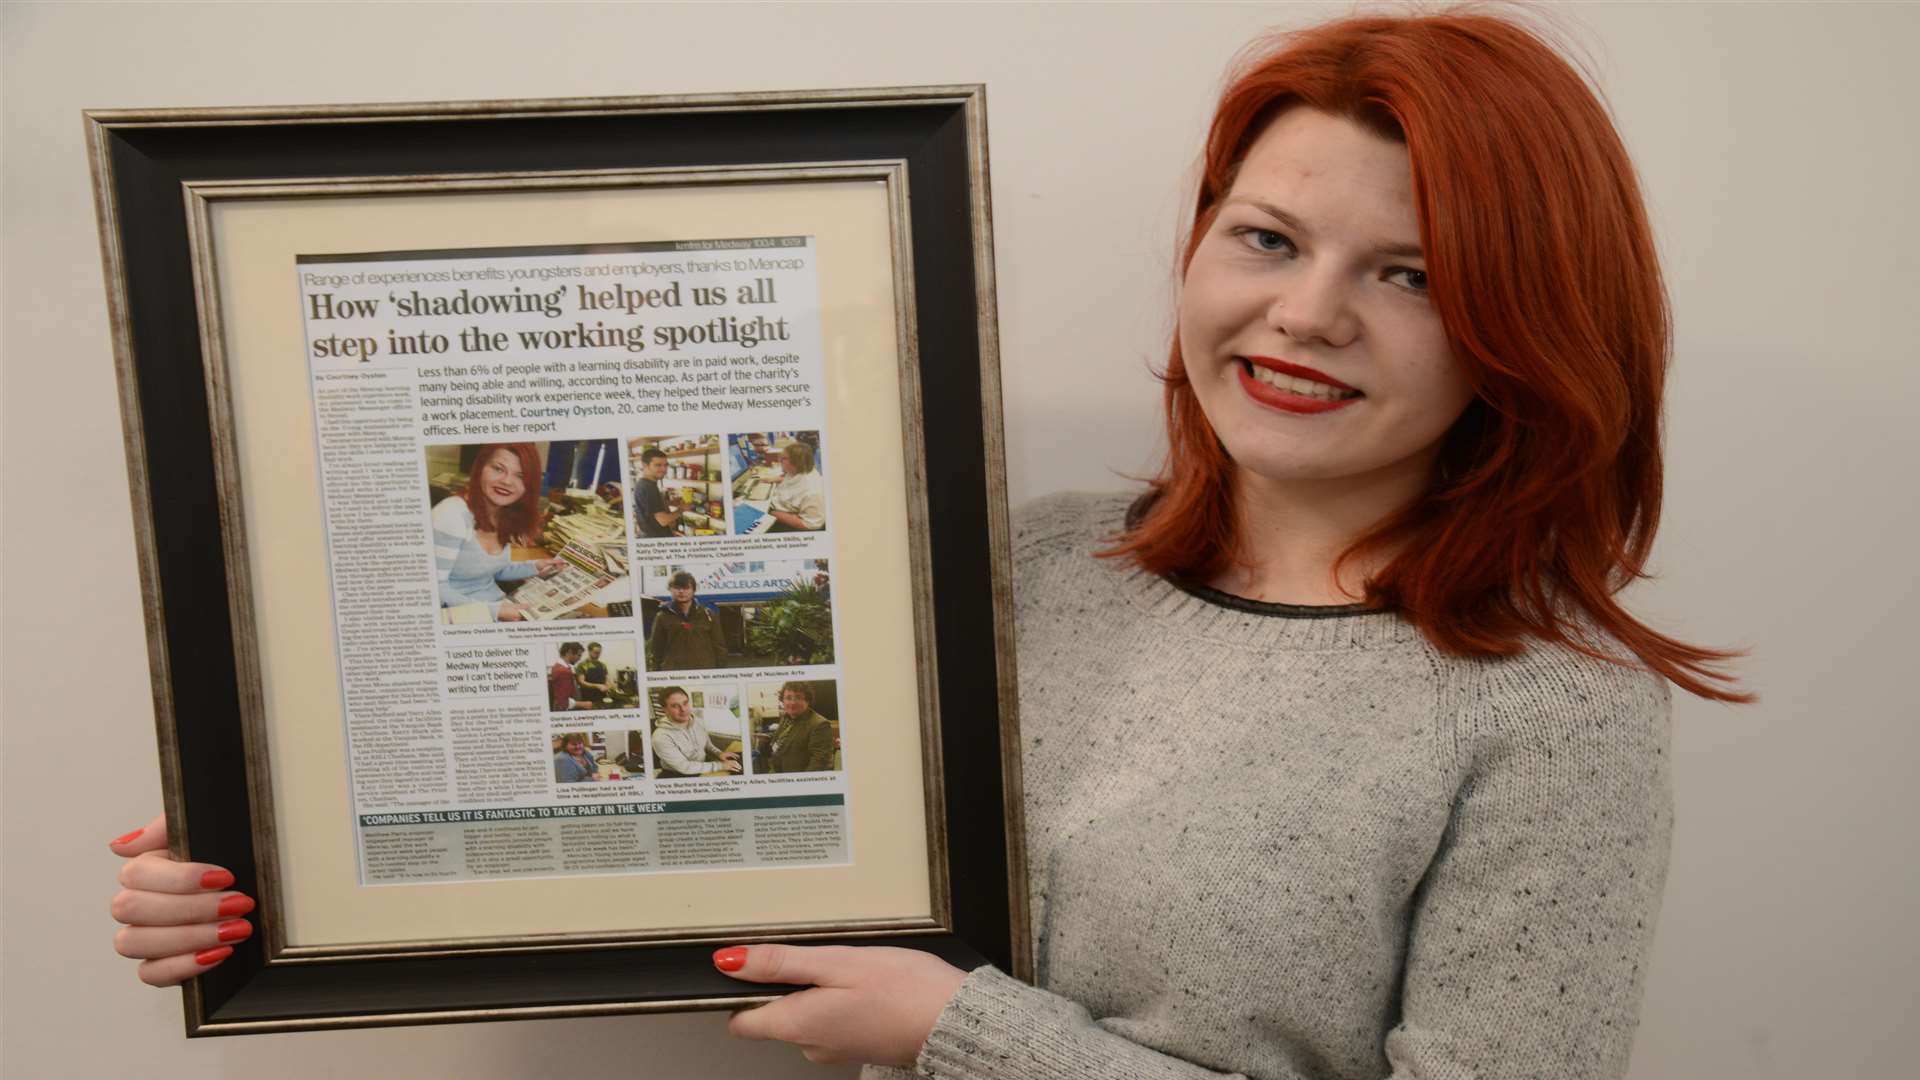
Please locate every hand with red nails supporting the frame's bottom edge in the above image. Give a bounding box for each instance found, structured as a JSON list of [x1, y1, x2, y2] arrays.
[[714, 945, 966, 1067]]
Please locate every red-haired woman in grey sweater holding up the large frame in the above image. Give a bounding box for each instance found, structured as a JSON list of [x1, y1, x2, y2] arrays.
[[117, 13, 1741, 1080]]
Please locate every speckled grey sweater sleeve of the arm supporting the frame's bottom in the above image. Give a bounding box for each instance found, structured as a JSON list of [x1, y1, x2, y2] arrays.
[[898, 638, 1672, 1080]]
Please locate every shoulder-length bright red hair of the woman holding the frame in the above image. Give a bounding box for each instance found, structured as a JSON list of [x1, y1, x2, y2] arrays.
[[1102, 13, 1753, 701]]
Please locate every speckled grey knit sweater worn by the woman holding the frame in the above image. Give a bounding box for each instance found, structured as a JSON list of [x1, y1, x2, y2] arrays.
[[872, 496, 1672, 1080]]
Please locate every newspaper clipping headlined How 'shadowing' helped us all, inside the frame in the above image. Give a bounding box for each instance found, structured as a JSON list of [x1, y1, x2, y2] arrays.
[[296, 236, 860, 884]]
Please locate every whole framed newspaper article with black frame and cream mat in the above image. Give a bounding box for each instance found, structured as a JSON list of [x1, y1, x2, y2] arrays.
[[86, 86, 1029, 1036]]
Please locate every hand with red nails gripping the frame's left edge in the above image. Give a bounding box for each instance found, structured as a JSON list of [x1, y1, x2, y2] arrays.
[[108, 815, 253, 986]]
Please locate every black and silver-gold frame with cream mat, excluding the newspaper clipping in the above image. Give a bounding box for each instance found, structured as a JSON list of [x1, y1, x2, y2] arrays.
[[84, 86, 1031, 1036]]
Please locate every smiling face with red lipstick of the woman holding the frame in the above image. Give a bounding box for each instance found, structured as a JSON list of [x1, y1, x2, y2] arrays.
[[1179, 108, 1473, 490]]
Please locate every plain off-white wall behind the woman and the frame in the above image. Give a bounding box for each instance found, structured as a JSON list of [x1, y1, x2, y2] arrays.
[[0, 4, 1920, 1080]]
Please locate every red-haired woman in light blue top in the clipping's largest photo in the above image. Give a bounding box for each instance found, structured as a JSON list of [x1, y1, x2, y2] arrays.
[[434, 442, 566, 623]]
